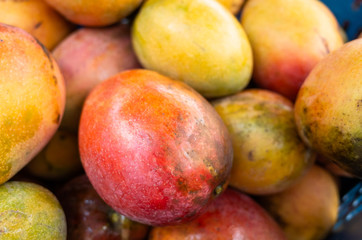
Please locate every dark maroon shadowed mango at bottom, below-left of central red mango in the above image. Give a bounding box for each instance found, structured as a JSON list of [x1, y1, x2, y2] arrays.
[[57, 175, 149, 240]]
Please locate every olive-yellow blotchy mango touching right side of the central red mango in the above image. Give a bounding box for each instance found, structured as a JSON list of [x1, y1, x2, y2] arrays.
[[212, 89, 315, 195]]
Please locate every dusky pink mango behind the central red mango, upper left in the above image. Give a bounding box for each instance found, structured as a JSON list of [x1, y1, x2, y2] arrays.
[[53, 24, 141, 132]]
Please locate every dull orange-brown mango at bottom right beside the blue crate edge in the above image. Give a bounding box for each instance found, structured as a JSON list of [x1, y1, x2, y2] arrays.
[[259, 165, 339, 240]]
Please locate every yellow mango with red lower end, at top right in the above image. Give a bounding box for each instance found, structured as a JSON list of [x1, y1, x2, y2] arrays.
[[241, 0, 343, 101]]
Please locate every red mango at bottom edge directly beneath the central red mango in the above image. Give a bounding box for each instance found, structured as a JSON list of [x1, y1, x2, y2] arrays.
[[149, 188, 286, 240]]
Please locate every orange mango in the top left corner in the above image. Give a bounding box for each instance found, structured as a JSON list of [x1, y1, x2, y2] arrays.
[[0, 0, 73, 50]]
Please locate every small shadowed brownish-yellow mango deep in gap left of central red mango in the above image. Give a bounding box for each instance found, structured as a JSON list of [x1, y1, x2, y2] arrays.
[[26, 130, 82, 180]]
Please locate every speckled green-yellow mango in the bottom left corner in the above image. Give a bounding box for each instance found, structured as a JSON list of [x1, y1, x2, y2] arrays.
[[0, 181, 67, 240]]
